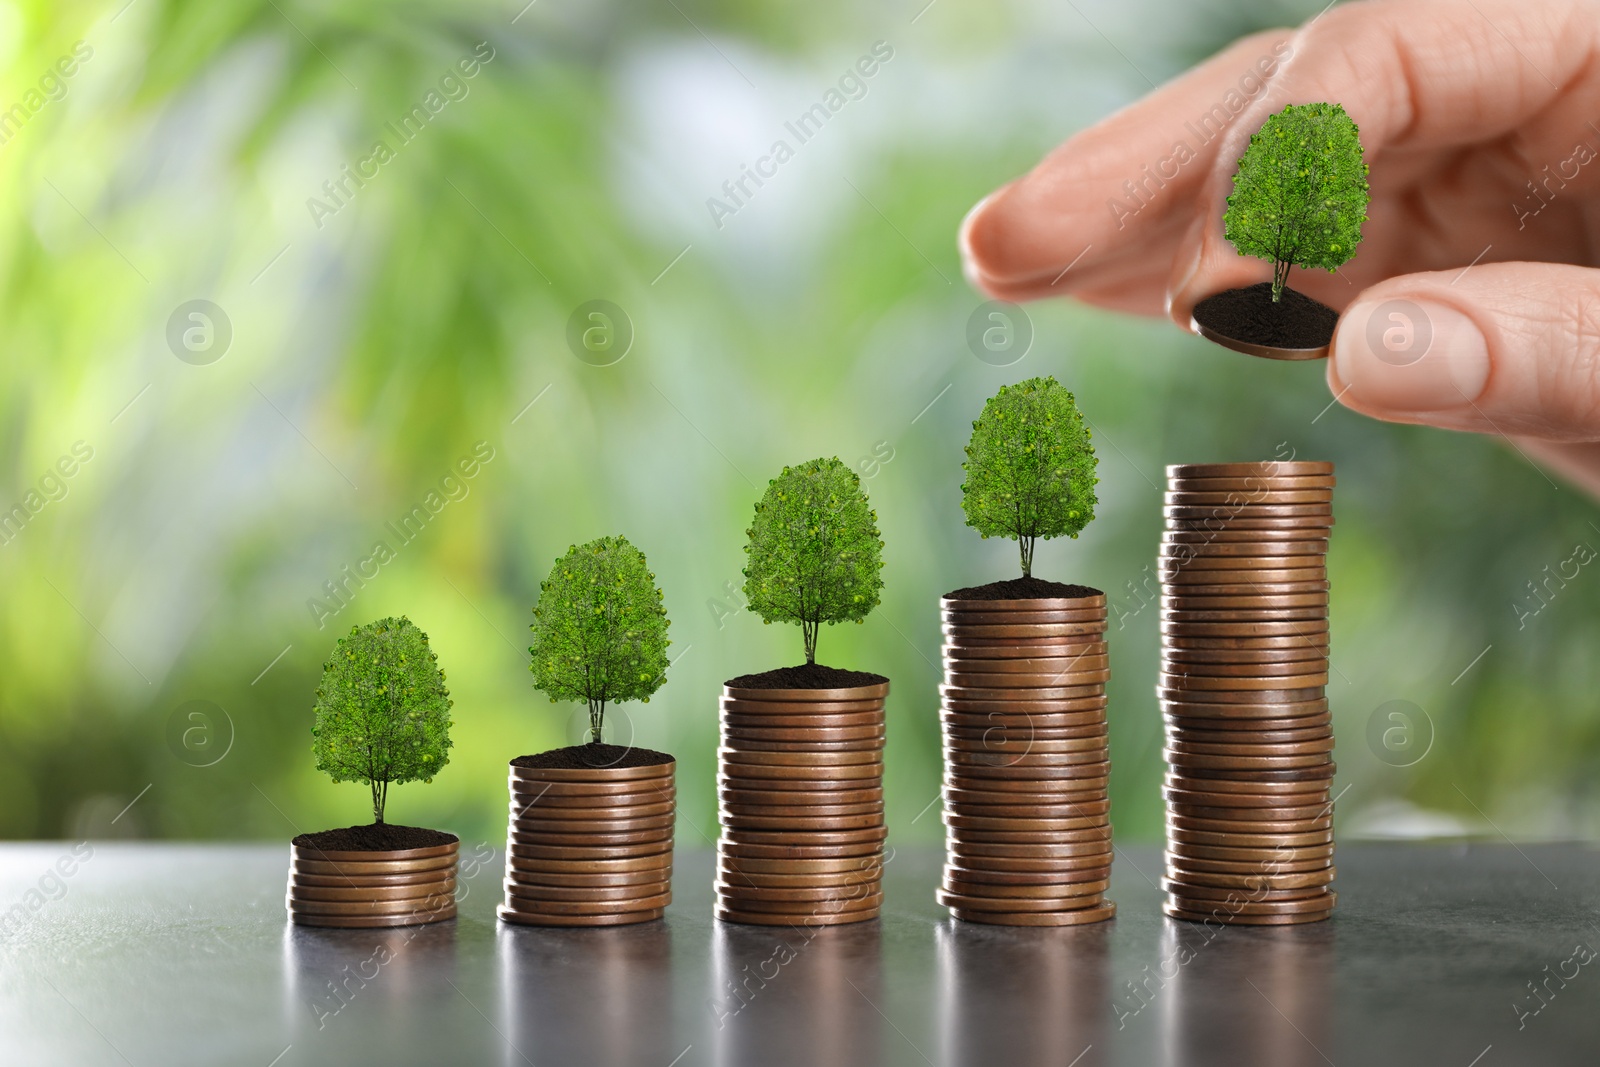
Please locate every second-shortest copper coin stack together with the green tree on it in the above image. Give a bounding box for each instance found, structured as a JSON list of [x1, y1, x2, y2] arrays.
[[499, 536, 677, 926]]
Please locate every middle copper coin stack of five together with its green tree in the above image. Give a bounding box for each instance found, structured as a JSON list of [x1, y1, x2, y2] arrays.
[[715, 458, 890, 926]]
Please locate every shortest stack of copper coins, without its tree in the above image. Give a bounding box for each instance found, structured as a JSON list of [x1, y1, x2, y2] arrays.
[[288, 840, 461, 926]]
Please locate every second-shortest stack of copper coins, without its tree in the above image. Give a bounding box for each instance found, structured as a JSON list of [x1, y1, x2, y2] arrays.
[[499, 763, 677, 926]]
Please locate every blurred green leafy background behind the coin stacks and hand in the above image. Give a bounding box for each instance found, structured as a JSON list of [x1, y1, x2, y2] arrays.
[[0, 0, 1600, 846]]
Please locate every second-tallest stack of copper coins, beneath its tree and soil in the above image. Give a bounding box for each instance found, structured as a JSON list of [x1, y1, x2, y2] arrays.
[[938, 593, 1117, 926]]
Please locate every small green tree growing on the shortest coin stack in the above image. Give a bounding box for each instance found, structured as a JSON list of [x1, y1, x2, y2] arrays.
[[310, 616, 453, 822]]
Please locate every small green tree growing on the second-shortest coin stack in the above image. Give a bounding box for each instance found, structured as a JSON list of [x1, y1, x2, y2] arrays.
[[528, 537, 670, 744]]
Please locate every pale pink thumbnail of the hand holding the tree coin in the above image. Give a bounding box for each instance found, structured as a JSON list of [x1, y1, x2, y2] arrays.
[[1333, 299, 1490, 413]]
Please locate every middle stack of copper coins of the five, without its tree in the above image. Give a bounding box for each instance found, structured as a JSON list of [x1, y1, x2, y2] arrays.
[[717, 681, 890, 926]]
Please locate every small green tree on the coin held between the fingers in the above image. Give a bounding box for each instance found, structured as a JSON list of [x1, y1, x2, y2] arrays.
[[1222, 104, 1368, 302]]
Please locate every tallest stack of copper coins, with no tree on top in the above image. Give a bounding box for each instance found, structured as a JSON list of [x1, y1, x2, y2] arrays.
[[1157, 461, 1336, 925]]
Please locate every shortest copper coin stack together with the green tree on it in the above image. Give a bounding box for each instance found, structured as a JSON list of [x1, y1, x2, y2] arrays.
[[288, 616, 459, 926]]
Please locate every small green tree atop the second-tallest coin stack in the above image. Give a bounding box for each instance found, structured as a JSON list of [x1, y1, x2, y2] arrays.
[[962, 378, 1099, 577]]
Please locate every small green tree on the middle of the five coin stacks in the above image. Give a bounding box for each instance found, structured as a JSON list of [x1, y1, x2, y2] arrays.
[[744, 456, 883, 664]]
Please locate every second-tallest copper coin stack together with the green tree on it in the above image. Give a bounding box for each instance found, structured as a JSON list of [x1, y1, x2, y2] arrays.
[[938, 378, 1117, 926]]
